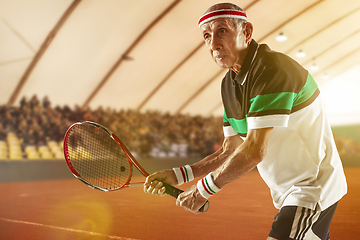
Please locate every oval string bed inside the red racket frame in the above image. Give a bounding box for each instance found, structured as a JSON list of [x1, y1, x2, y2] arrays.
[[68, 124, 132, 190]]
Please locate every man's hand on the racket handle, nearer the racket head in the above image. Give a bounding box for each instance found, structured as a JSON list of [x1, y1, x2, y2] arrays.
[[144, 169, 177, 196]]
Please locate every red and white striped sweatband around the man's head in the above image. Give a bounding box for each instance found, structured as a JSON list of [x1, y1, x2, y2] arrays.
[[198, 9, 247, 28]]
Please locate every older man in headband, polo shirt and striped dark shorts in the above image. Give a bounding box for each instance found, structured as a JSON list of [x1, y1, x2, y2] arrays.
[[144, 3, 347, 240]]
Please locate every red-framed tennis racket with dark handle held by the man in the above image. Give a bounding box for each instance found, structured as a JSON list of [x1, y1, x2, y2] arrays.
[[64, 121, 209, 212]]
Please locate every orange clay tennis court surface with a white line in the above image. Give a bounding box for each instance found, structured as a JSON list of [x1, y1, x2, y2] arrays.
[[0, 168, 360, 240]]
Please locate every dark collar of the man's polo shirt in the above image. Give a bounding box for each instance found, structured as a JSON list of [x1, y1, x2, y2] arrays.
[[229, 39, 259, 85]]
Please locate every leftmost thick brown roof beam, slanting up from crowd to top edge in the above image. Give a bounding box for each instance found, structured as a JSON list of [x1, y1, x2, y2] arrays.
[[7, 0, 82, 105]]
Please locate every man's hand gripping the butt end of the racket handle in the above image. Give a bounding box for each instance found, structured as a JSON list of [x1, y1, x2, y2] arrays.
[[176, 185, 207, 214]]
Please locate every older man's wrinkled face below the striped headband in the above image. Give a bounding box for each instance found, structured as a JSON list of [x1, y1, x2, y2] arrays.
[[201, 18, 247, 69]]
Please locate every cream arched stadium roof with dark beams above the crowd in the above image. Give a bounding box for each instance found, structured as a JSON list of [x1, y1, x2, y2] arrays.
[[0, 0, 360, 124]]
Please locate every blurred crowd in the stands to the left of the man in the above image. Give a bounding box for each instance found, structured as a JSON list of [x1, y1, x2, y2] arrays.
[[0, 95, 223, 157]]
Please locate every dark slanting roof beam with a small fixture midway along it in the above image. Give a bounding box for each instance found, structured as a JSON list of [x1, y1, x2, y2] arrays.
[[83, 0, 180, 107]]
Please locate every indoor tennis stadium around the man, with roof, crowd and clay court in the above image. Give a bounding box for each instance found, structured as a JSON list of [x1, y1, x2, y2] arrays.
[[0, 0, 360, 240]]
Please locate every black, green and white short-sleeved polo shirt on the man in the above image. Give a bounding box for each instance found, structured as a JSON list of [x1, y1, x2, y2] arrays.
[[221, 40, 347, 210]]
